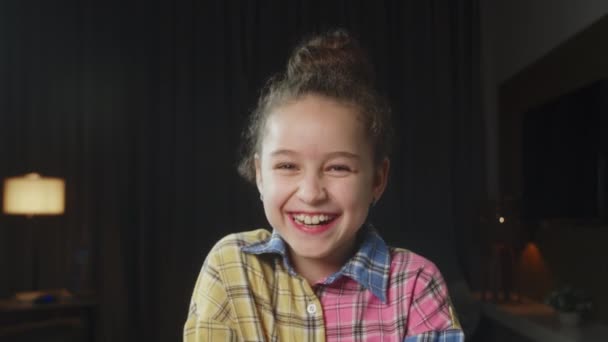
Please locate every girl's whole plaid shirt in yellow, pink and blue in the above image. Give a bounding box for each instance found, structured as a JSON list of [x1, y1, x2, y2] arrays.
[[184, 229, 464, 342]]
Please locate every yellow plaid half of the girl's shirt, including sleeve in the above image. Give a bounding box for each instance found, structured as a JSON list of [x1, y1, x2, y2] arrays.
[[184, 229, 325, 342]]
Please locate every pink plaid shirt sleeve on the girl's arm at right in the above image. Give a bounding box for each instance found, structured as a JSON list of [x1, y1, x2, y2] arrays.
[[405, 262, 464, 342]]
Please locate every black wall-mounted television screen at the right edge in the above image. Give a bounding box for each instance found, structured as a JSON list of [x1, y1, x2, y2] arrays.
[[521, 80, 608, 222]]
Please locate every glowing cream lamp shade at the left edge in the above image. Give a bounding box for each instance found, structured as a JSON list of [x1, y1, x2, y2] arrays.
[[2, 173, 65, 216]]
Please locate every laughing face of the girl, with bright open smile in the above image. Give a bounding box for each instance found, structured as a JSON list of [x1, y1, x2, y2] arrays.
[[255, 95, 389, 270]]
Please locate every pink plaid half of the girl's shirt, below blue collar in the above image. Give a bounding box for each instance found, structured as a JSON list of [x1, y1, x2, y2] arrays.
[[317, 249, 458, 342]]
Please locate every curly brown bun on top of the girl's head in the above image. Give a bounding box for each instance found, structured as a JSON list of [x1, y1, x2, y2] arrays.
[[287, 30, 375, 84]]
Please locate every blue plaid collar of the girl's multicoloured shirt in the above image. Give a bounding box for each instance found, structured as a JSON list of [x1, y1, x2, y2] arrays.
[[241, 225, 390, 302]]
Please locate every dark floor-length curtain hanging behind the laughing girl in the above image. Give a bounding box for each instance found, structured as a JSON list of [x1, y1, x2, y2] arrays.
[[0, 0, 485, 341]]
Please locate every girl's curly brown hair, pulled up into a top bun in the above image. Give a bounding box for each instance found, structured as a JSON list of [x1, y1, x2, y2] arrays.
[[238, 29, 393, 183]]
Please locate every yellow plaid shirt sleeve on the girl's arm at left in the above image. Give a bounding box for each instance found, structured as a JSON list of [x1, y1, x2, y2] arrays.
[[183, 250, 238, 342]]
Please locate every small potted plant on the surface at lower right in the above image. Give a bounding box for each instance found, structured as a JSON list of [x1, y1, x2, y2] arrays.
[[546, 286, 591, 326]]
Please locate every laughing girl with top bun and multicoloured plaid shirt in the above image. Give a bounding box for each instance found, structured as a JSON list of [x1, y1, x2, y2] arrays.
[[184, 31, 464, 342]]
